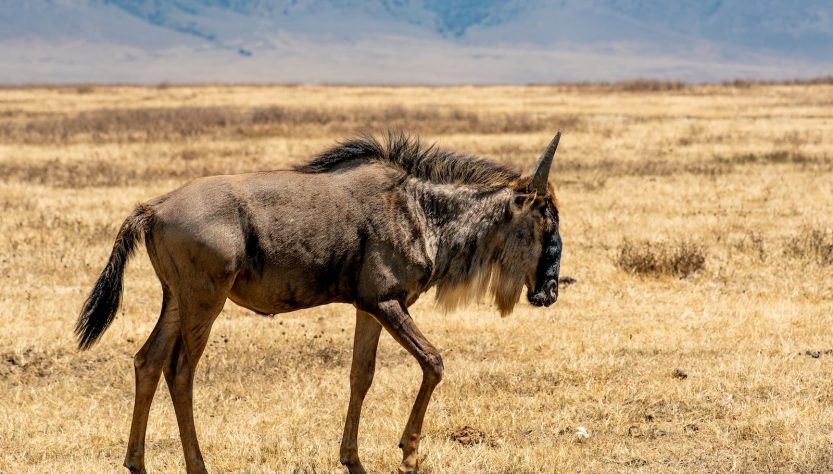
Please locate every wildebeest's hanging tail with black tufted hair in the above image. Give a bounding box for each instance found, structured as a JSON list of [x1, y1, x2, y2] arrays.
[[75, 204, 153, 350]]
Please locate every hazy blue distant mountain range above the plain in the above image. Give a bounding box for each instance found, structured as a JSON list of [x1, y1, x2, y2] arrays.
[[0, 0, 833, 83]]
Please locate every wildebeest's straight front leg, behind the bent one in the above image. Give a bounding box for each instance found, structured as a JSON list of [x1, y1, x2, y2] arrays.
[[340, 310, 382, 474]]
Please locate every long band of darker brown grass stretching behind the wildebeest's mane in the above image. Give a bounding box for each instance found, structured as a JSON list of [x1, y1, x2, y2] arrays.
[[0, 102, 578, 144]]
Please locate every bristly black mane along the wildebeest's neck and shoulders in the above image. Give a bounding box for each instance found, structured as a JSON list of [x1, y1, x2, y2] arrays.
[[295, 132, 520, 188]]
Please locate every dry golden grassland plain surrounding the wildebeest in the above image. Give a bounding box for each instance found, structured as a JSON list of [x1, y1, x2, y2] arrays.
[[0, 83, 833, 473]]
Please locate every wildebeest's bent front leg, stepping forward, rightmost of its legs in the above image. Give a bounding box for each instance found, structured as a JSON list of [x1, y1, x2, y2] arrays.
[[374, 300, 443, 473]]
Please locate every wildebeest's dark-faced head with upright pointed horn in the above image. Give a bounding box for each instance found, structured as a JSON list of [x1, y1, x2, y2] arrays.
[[507, 130, 562, 306]]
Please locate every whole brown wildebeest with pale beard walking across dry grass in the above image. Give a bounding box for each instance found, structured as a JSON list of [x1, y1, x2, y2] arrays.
[[76, 130, 561, 473]]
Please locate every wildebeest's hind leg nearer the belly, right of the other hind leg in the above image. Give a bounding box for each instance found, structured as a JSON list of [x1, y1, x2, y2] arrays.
[[164, 278, 233, 474]]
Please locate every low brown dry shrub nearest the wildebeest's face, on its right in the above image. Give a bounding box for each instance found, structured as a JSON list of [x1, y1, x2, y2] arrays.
[[616, 240, 706, 278]]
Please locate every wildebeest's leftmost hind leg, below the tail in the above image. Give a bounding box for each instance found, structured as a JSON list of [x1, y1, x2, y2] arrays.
[[124, 289, 179, 473]]
